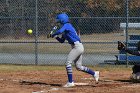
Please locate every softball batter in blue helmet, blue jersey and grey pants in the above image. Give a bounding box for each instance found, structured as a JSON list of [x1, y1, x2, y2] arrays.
[[52, 13, 99, 87]]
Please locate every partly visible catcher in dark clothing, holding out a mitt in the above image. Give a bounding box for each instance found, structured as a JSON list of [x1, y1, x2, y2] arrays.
[[118, 41, 140, 79]]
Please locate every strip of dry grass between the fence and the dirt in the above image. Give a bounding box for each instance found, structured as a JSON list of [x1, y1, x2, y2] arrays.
[[0, 64, 131, 73]]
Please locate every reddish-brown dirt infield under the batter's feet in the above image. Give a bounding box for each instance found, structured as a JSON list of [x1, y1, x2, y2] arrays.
[[0, 67, 140, 93]]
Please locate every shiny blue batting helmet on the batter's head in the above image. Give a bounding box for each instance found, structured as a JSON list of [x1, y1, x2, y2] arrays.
[[56, 13, 69, 24]]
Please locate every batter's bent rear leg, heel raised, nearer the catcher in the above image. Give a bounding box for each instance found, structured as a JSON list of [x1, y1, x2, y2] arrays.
[[74, 54, 99, 82]]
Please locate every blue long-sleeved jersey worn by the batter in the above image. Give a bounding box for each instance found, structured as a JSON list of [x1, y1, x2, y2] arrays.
[[53, 23, 81, 44]]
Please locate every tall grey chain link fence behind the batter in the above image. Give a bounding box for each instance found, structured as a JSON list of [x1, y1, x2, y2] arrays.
[[0, 0, 140, 65]]
